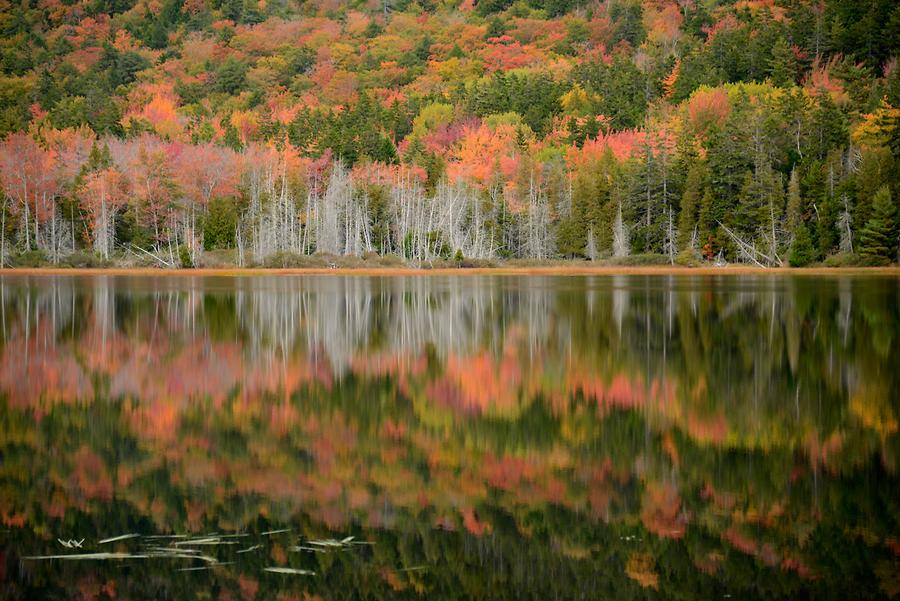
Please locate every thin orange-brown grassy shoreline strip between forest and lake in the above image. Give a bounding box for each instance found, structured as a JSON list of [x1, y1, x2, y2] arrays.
[[0, 265, 900, 277]]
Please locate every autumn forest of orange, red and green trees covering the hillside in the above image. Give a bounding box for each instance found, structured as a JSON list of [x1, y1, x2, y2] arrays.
[[0, 0, 900, 267]]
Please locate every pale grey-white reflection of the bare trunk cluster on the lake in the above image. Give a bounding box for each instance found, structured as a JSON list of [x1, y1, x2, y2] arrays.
[[229, 277, 549, 374]]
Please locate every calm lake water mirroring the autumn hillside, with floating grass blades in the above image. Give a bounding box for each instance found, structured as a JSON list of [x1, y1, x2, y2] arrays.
[[0, 276, 900, 599]]
